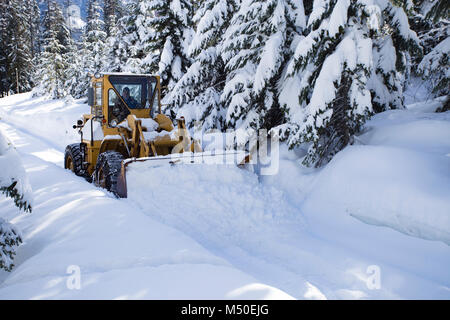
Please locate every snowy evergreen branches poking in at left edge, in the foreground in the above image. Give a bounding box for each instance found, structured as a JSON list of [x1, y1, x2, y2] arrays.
[[0, 132, 32, 271]]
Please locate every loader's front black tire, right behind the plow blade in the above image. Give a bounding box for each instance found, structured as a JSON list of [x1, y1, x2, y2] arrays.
[[94, 151, 124, 197]]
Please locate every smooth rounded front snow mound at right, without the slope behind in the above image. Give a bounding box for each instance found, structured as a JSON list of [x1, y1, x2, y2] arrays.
[[304, 146, 450, 245]]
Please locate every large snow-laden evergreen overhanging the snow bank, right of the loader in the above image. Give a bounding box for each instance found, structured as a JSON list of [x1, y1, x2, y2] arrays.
[[277, 0, 420, 166]]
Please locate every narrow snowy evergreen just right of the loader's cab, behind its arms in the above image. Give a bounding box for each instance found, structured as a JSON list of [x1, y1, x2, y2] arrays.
[[166, 0, 243, 129]]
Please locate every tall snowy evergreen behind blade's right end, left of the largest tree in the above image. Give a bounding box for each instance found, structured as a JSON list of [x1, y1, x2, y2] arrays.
[[221, 0, 305, 129]]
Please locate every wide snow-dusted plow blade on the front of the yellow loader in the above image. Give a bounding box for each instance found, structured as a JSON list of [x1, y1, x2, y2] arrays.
[[116, 151, 250, 198]]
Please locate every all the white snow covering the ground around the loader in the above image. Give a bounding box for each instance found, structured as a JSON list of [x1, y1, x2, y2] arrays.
[[0, 94, 450, 299]]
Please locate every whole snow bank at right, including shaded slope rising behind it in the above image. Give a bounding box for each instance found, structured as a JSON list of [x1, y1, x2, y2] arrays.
[[303, 101, 450, 245]]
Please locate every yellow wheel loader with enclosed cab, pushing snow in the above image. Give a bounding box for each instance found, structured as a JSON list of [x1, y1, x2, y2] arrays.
[[64, 73, 248, 198]]
